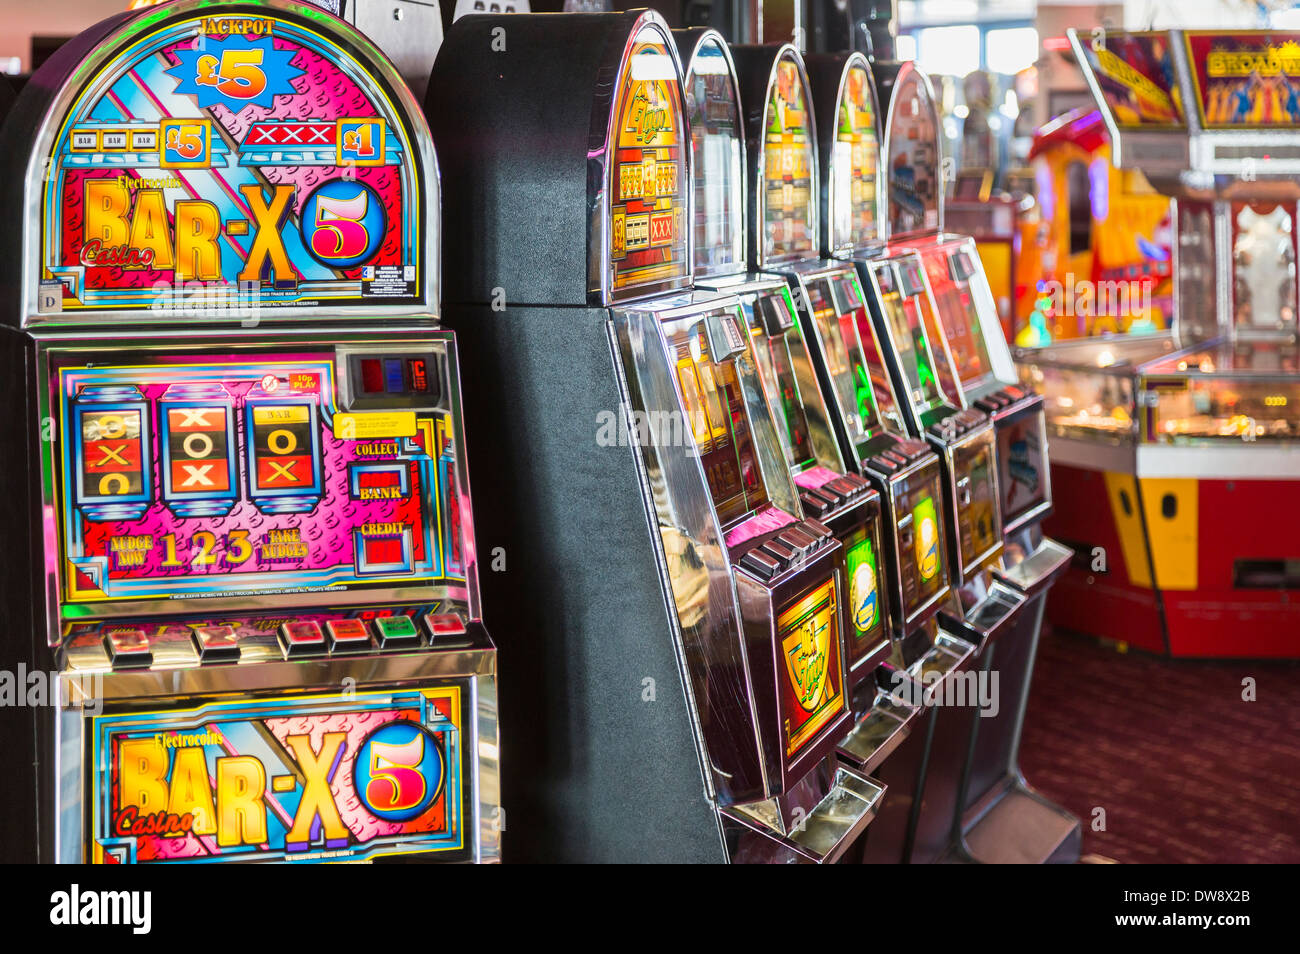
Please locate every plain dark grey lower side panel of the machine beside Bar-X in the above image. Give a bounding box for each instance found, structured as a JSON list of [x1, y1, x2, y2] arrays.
[[446, 307, 723, 862]]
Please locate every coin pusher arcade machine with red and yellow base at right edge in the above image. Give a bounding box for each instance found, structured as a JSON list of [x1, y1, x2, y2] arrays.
[[1017, 31, 1300, 658]]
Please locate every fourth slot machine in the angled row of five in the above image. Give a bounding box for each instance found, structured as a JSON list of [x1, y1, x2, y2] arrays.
[[810, 55, 1066, 860]]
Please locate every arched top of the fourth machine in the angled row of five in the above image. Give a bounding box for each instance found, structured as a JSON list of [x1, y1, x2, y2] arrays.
[[806, 52, 884, 257]]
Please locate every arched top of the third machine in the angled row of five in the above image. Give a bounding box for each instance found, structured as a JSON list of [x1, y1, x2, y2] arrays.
[[732, 43, 820, 268]]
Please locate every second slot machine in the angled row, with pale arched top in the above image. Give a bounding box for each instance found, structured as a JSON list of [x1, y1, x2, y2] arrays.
[[673, 29, 922, 857]]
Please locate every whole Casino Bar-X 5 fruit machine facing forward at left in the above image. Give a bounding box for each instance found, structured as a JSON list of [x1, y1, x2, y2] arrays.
[[0, 0, 501, 864]]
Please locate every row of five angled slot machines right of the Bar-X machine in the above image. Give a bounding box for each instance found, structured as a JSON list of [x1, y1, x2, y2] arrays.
[[425, 12, 1079, 862]]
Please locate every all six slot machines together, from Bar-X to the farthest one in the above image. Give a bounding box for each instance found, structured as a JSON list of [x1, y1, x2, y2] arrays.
[[0, 0, 1079, 863]]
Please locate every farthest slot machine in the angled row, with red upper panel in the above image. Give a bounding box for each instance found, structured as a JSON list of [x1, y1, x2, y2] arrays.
[[867, 64, 1079, 860]]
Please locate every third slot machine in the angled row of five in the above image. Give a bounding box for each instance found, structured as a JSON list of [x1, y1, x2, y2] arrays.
[[733, 45, 993, 860]]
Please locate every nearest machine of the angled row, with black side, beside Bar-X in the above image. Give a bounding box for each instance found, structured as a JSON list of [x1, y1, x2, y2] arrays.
[[425, 10, 884, 862]]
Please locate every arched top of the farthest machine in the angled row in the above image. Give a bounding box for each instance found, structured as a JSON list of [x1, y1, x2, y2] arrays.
[[876, 62, 944, 239]]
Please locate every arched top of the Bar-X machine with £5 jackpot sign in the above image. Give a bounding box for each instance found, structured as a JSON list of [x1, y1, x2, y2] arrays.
[[0, 0, 439, 328]]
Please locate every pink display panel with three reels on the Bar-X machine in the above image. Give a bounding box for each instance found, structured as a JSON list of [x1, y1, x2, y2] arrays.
[[57, 352, 464, 604]]
